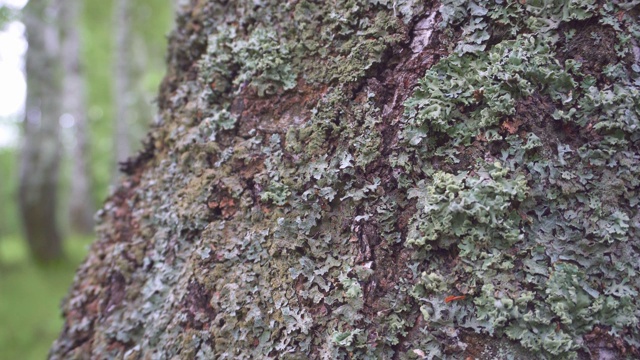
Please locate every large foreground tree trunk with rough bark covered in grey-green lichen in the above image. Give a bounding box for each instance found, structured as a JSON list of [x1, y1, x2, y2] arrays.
[[51, 0, 640, 359]]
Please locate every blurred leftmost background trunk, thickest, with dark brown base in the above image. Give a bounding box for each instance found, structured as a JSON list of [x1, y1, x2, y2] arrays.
[[19, 1, 62, 262]]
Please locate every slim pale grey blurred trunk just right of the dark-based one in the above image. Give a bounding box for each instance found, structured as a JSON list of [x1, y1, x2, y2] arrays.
[[60, 0, 95, 234]]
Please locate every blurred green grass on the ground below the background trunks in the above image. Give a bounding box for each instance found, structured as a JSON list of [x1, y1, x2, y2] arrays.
[[0, 237, 92, 360]]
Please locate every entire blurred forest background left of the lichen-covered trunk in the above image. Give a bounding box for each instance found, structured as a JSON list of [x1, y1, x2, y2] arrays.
[[0, 0, 179, 360]]
